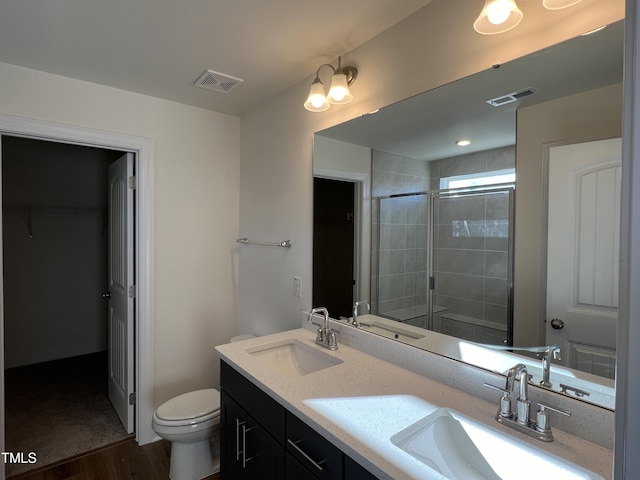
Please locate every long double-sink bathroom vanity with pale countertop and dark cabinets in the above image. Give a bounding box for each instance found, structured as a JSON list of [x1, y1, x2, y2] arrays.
[[216, 327, 612, 479]]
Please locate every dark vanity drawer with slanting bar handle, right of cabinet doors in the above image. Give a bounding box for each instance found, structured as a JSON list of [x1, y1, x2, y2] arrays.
[[286, 412, 343, 480]]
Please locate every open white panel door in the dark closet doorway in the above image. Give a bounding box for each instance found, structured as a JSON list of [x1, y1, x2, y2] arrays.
[[108, 153, 135, 433]]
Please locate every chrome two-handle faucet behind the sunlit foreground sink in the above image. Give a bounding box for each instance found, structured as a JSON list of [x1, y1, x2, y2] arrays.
[[484, 363, 571, 442]]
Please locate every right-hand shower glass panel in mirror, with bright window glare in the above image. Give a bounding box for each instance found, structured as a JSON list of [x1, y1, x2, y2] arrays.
[[428, 188, 513, 345]]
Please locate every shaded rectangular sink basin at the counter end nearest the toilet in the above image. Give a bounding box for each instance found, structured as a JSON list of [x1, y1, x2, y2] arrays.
[[246, 339, 342, 378]]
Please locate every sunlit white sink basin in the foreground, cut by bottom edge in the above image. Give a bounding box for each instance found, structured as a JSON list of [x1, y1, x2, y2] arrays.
[[391, 408, 602, 480]]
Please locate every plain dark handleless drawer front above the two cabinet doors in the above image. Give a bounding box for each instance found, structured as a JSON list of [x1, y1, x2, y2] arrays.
[[220, 361, 286, 445]]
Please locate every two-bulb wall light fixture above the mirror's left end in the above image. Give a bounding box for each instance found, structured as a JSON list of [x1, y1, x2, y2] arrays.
[[304, 57, 358, 112]]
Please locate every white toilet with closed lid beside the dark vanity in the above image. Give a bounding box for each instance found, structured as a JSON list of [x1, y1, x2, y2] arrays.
[[152, 388, 220, 480]]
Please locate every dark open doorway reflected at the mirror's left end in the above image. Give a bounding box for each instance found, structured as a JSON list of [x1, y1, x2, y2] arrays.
[[313, 177, 356, 318]]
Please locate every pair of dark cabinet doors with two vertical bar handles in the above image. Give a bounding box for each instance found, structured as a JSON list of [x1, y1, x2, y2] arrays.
[[220, 390, 284, 480]]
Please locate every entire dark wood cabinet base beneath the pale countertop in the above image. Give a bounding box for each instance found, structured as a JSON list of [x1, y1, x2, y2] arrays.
[[220, 361, 376, 480]]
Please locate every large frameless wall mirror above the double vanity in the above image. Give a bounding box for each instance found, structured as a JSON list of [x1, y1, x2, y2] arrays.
[[313, 22, 624, 409]]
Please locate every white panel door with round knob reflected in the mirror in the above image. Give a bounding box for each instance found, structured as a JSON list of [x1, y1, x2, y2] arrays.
[[546, 138, 622, 378]]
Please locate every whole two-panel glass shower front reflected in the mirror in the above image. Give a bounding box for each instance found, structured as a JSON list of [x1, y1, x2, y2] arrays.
[[372, 185, 514, 345]]
